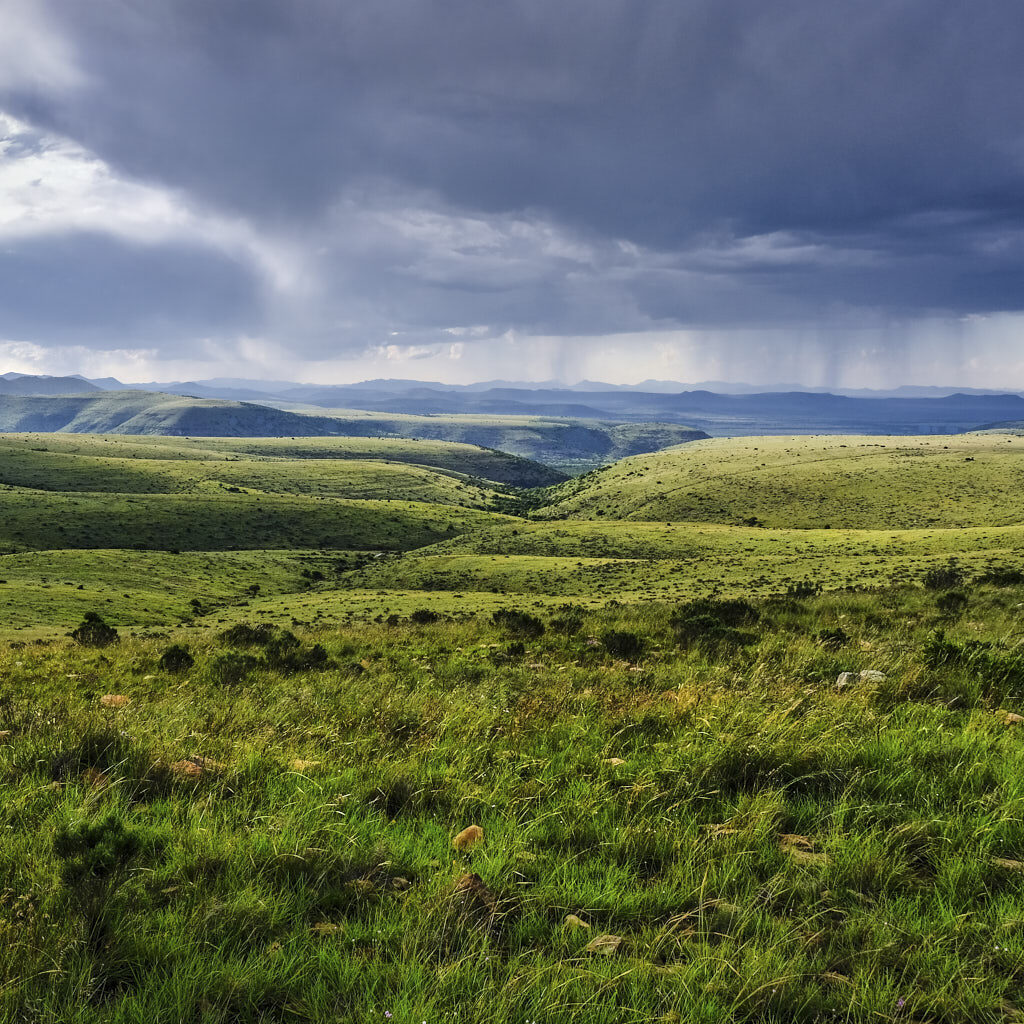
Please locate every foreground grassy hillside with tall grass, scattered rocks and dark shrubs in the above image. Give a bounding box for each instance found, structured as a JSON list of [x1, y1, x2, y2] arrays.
[[6, 587, 1024, 1024]]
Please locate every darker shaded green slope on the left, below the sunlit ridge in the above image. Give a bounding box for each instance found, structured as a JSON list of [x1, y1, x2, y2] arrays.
[[0, 488, 500, 552]]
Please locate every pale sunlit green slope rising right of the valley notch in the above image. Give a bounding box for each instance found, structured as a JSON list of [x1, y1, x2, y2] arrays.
[[543, 434, 1024, 529]]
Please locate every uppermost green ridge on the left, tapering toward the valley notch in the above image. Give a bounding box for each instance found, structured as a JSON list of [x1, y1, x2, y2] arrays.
[[0, 434, 564, 489]]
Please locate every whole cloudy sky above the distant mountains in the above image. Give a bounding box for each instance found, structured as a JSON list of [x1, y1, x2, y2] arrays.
[[0, 0, 1024, 388]]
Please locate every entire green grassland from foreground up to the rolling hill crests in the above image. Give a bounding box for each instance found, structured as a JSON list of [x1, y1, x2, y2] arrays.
[[6, 434, 1024, 1024]]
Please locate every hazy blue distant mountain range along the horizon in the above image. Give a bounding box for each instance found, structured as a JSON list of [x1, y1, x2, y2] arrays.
[[0, 374, 1024, 444]]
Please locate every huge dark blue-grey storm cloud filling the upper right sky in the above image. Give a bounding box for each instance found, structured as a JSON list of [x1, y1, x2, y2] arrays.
[[0, 0, 1024, 372]]
